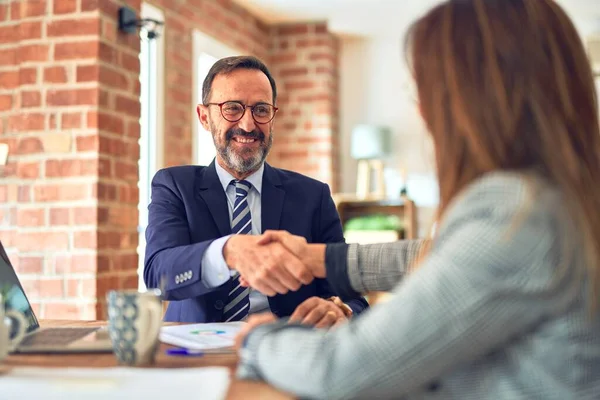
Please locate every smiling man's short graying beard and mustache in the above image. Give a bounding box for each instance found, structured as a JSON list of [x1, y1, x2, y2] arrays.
[[211, 124, 273, 174]]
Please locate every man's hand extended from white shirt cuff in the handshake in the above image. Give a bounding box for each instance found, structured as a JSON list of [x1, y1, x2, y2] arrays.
[[223, 235, 313, 296]]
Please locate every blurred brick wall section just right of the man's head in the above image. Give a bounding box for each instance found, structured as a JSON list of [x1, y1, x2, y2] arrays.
[[270, 23, 339, 191]]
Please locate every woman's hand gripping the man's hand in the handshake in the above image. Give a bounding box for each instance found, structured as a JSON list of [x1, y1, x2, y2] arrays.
[[258, 230, 326, 278]]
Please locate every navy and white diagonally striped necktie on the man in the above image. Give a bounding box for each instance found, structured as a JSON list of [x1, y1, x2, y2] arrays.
[[223, 180, 252, 322]]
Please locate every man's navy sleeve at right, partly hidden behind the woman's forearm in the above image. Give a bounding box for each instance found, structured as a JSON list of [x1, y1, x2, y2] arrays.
[[315, 184, 369, 315]]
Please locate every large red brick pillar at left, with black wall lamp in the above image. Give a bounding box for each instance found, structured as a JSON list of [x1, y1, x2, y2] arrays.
[[0, 0, 139, 318]]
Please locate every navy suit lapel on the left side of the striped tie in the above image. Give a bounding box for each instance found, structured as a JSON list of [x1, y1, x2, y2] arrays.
[[196, 160, 231, 236]]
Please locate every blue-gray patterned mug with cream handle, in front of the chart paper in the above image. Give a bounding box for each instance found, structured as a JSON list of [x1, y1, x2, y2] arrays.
[[106, 289, 162, 366]]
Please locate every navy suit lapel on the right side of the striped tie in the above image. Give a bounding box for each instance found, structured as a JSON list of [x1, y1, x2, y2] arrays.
[[260, 163, 285, 232]]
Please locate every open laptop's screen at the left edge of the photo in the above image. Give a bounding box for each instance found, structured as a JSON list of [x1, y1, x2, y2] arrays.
[[0, 242, 40, 332]]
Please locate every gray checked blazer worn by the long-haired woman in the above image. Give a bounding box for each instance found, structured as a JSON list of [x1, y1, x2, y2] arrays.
[[237, 172, 600, 400]]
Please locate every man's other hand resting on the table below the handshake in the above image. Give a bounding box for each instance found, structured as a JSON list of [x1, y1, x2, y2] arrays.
[[289, 297, 346, 328]]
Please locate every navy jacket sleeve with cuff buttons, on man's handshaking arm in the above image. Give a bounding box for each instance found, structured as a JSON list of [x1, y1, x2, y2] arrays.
[[144, 169, 224, 300]]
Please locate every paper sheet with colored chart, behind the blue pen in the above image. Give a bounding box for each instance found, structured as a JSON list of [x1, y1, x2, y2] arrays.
[[160, 322, 245, 352]]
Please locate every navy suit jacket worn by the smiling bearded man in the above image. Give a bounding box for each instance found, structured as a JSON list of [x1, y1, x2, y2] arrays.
[[144, 161, 368, 322]]
